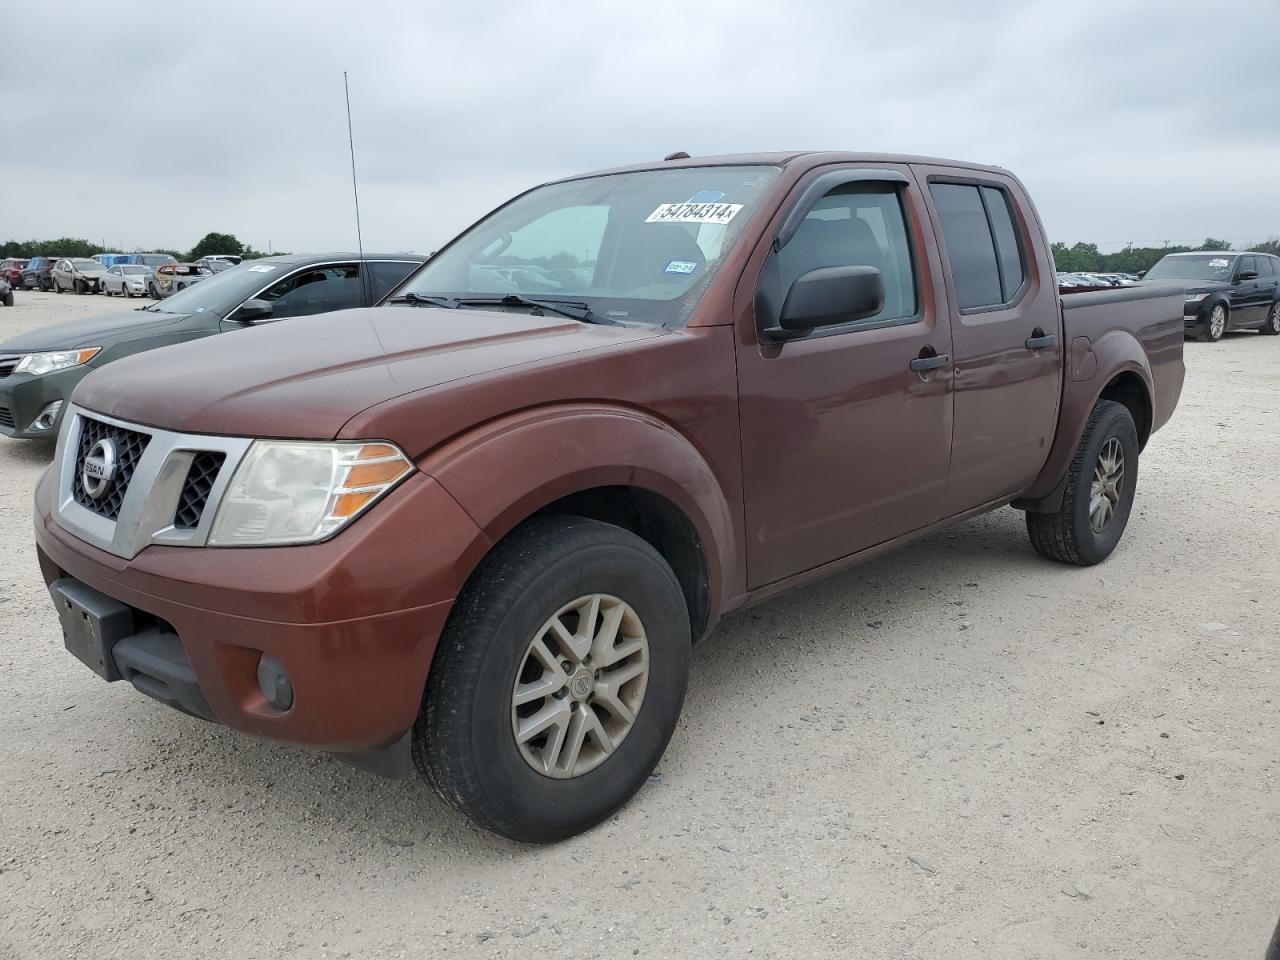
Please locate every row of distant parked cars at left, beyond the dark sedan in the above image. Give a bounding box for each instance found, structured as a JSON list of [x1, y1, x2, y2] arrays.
[[0, 253, 241, 306]]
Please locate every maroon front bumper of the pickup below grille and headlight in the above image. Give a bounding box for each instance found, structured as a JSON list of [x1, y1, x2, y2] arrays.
[[35, 470, 483, 753]]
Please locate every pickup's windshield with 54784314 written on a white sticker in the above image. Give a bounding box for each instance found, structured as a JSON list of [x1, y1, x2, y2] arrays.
[[396, 166, 778, 325]]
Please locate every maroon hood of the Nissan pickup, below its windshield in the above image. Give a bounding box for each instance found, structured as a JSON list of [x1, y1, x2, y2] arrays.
[[74, 307, 666, 442]]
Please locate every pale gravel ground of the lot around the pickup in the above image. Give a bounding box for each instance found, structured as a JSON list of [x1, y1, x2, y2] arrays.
[[0, 293, 1280, 960]]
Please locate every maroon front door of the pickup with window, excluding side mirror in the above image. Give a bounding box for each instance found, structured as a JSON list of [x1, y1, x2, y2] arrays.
[[737, 165, 951, 589]]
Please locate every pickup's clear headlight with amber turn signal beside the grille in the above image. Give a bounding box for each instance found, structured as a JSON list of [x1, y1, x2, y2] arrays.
[[209, 440, 413, 547]]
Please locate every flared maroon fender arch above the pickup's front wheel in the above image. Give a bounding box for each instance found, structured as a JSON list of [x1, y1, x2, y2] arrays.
[[419, 404, 745, 622]]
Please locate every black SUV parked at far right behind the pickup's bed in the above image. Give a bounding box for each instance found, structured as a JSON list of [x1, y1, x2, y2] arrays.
[[1143, 251, 1280, 340]]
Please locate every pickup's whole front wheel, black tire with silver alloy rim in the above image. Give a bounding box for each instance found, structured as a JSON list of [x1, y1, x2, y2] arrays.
[[413, 517, 690, 842]]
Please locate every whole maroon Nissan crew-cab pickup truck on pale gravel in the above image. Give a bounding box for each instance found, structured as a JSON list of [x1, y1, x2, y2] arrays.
[[36, 154, 1183, 841]]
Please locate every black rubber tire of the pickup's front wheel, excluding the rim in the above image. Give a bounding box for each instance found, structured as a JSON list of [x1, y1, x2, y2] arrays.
[[413, 517, 690, 842]]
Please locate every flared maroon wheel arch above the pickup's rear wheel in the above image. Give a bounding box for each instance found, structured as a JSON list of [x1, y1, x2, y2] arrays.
[[1015, 330, 1155, 509]]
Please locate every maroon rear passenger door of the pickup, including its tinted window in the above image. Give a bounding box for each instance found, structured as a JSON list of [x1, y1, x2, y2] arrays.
[[915, 166, 1062, 516]]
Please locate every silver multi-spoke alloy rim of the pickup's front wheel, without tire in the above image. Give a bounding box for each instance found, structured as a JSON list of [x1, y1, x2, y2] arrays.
[[511, 594, 649, 780]]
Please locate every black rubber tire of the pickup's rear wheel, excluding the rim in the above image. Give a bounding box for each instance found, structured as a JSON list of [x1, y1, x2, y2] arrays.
[[1027, 401, 1138, 567]]
